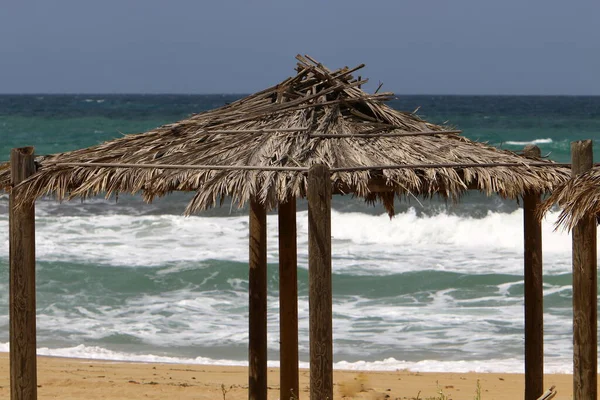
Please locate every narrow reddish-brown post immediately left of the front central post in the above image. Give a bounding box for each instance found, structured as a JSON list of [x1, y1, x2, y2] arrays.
[[279, 196, 300, 400]]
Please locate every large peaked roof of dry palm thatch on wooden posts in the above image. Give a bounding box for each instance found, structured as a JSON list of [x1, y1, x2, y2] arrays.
[[0, 56, 569, 214]]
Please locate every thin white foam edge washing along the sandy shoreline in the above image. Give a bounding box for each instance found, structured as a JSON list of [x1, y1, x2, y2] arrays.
[[0, 343, 572, 374]]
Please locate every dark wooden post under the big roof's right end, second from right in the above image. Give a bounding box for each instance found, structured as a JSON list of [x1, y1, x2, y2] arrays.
[[523, 146, 544, 400]]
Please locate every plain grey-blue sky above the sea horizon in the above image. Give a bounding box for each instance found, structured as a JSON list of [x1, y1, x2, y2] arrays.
[[0, 0, 600, 95]]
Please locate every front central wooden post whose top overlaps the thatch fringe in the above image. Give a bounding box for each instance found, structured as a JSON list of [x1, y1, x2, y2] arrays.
[[307, 165, 333, 400]]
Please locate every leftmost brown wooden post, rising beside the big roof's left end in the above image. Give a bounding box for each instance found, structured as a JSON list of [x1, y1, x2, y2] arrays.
[[9, 147, 37, 400]]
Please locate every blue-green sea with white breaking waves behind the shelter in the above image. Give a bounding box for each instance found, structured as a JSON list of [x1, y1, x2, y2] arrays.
[[0, 94, 600, 373]]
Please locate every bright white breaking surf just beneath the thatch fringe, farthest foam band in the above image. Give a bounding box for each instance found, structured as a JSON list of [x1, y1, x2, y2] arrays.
[[0, 209, 584, 274]]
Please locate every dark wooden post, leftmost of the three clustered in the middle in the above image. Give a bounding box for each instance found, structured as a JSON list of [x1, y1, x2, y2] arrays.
[[248, 199, 267, 400]]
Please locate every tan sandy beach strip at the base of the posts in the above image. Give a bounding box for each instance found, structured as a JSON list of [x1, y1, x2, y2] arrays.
[[0, 353, 572, 400]]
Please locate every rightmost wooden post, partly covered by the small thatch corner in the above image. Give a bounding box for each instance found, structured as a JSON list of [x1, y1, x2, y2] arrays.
[[571, 140, 598, 400]]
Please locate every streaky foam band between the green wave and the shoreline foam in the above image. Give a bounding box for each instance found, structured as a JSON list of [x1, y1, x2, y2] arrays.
[[5, 282, 572, 376]]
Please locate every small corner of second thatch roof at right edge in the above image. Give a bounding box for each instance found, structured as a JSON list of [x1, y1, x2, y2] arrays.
[[539, 167, 600, 230]]
